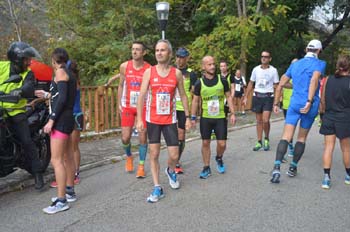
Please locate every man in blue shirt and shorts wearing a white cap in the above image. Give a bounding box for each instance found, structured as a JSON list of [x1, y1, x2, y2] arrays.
[[271, 40, 326, 183]]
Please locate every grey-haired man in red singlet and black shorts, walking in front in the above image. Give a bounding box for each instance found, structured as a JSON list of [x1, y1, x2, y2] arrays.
[[137, 40, 191, 202]]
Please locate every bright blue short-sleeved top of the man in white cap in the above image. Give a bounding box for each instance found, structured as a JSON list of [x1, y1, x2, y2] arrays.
[[285, 55, 326, 105]]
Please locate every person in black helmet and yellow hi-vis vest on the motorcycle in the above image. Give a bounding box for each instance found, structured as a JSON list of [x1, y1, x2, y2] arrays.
[[0, 42, 44, 190]]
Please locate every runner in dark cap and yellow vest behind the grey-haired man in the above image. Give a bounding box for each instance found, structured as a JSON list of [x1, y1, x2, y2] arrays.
[[175, 47, 197, 174]]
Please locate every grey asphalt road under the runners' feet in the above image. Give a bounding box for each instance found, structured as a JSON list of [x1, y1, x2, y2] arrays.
[[0, 121, 350, 232]]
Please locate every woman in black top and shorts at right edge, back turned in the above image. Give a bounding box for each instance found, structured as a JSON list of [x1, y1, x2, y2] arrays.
[[320, 56, 350, 189]]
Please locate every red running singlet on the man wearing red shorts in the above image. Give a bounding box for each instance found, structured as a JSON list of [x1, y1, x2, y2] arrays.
[[121, 60, 150, 108]]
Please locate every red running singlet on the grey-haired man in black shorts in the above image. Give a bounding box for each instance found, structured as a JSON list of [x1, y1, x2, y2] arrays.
[[146, 66, 177, 125]]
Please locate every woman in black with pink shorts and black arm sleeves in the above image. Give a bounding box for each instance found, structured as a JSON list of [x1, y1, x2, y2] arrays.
[[43, 48, 76, 214]]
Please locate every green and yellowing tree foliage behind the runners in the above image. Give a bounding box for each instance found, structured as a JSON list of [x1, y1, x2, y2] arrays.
[[0, 0, 350, 82]]
